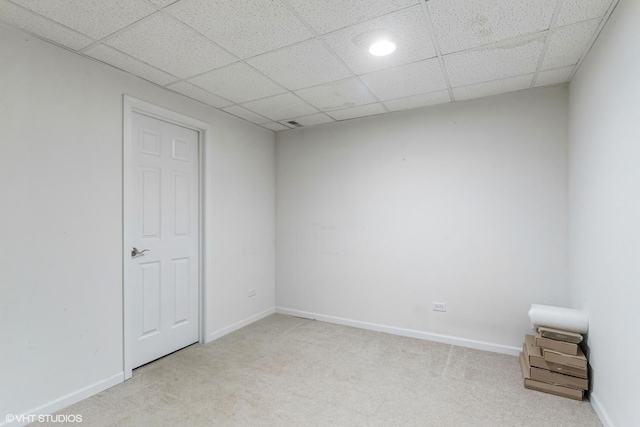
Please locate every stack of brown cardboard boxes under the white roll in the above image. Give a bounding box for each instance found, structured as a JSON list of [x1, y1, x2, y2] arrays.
[[520, 327, 589, 400]]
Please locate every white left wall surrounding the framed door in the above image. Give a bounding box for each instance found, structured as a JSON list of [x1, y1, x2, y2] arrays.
[[0, 25, 275, 422]]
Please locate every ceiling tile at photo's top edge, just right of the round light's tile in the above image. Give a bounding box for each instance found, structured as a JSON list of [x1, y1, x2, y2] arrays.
[[427, 0, 557, 55]]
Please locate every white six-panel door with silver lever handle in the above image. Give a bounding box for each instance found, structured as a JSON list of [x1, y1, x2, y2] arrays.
[[127, 113, 199, 368]]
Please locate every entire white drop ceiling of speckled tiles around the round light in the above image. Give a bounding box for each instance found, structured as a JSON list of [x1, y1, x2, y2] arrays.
[[0, 0, 616, 131]]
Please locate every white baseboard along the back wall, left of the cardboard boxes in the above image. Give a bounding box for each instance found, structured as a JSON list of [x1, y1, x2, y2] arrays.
[[276, 307, 522, 356]]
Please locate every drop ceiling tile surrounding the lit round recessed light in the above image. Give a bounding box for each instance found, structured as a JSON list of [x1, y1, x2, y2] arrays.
[[325, 5, 436, 74]]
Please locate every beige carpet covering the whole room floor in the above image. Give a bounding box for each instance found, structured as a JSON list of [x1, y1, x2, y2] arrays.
[[36, 315, 601, 427]]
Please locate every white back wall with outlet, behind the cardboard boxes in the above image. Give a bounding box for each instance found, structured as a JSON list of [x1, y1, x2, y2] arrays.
[[276, 86, 569, 354]]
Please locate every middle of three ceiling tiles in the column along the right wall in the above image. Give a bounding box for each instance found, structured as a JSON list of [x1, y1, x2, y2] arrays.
[[542, 18, 600, 70]]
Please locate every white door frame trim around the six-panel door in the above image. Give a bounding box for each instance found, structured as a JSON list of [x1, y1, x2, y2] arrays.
[[122, 95, 211, 380]]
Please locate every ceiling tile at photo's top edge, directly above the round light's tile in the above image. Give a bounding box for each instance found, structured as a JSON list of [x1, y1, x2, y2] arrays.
[[288, 0, 419, 34]]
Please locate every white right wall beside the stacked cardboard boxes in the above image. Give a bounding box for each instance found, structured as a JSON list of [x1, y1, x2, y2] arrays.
[[569, 0, 640, 426]]
